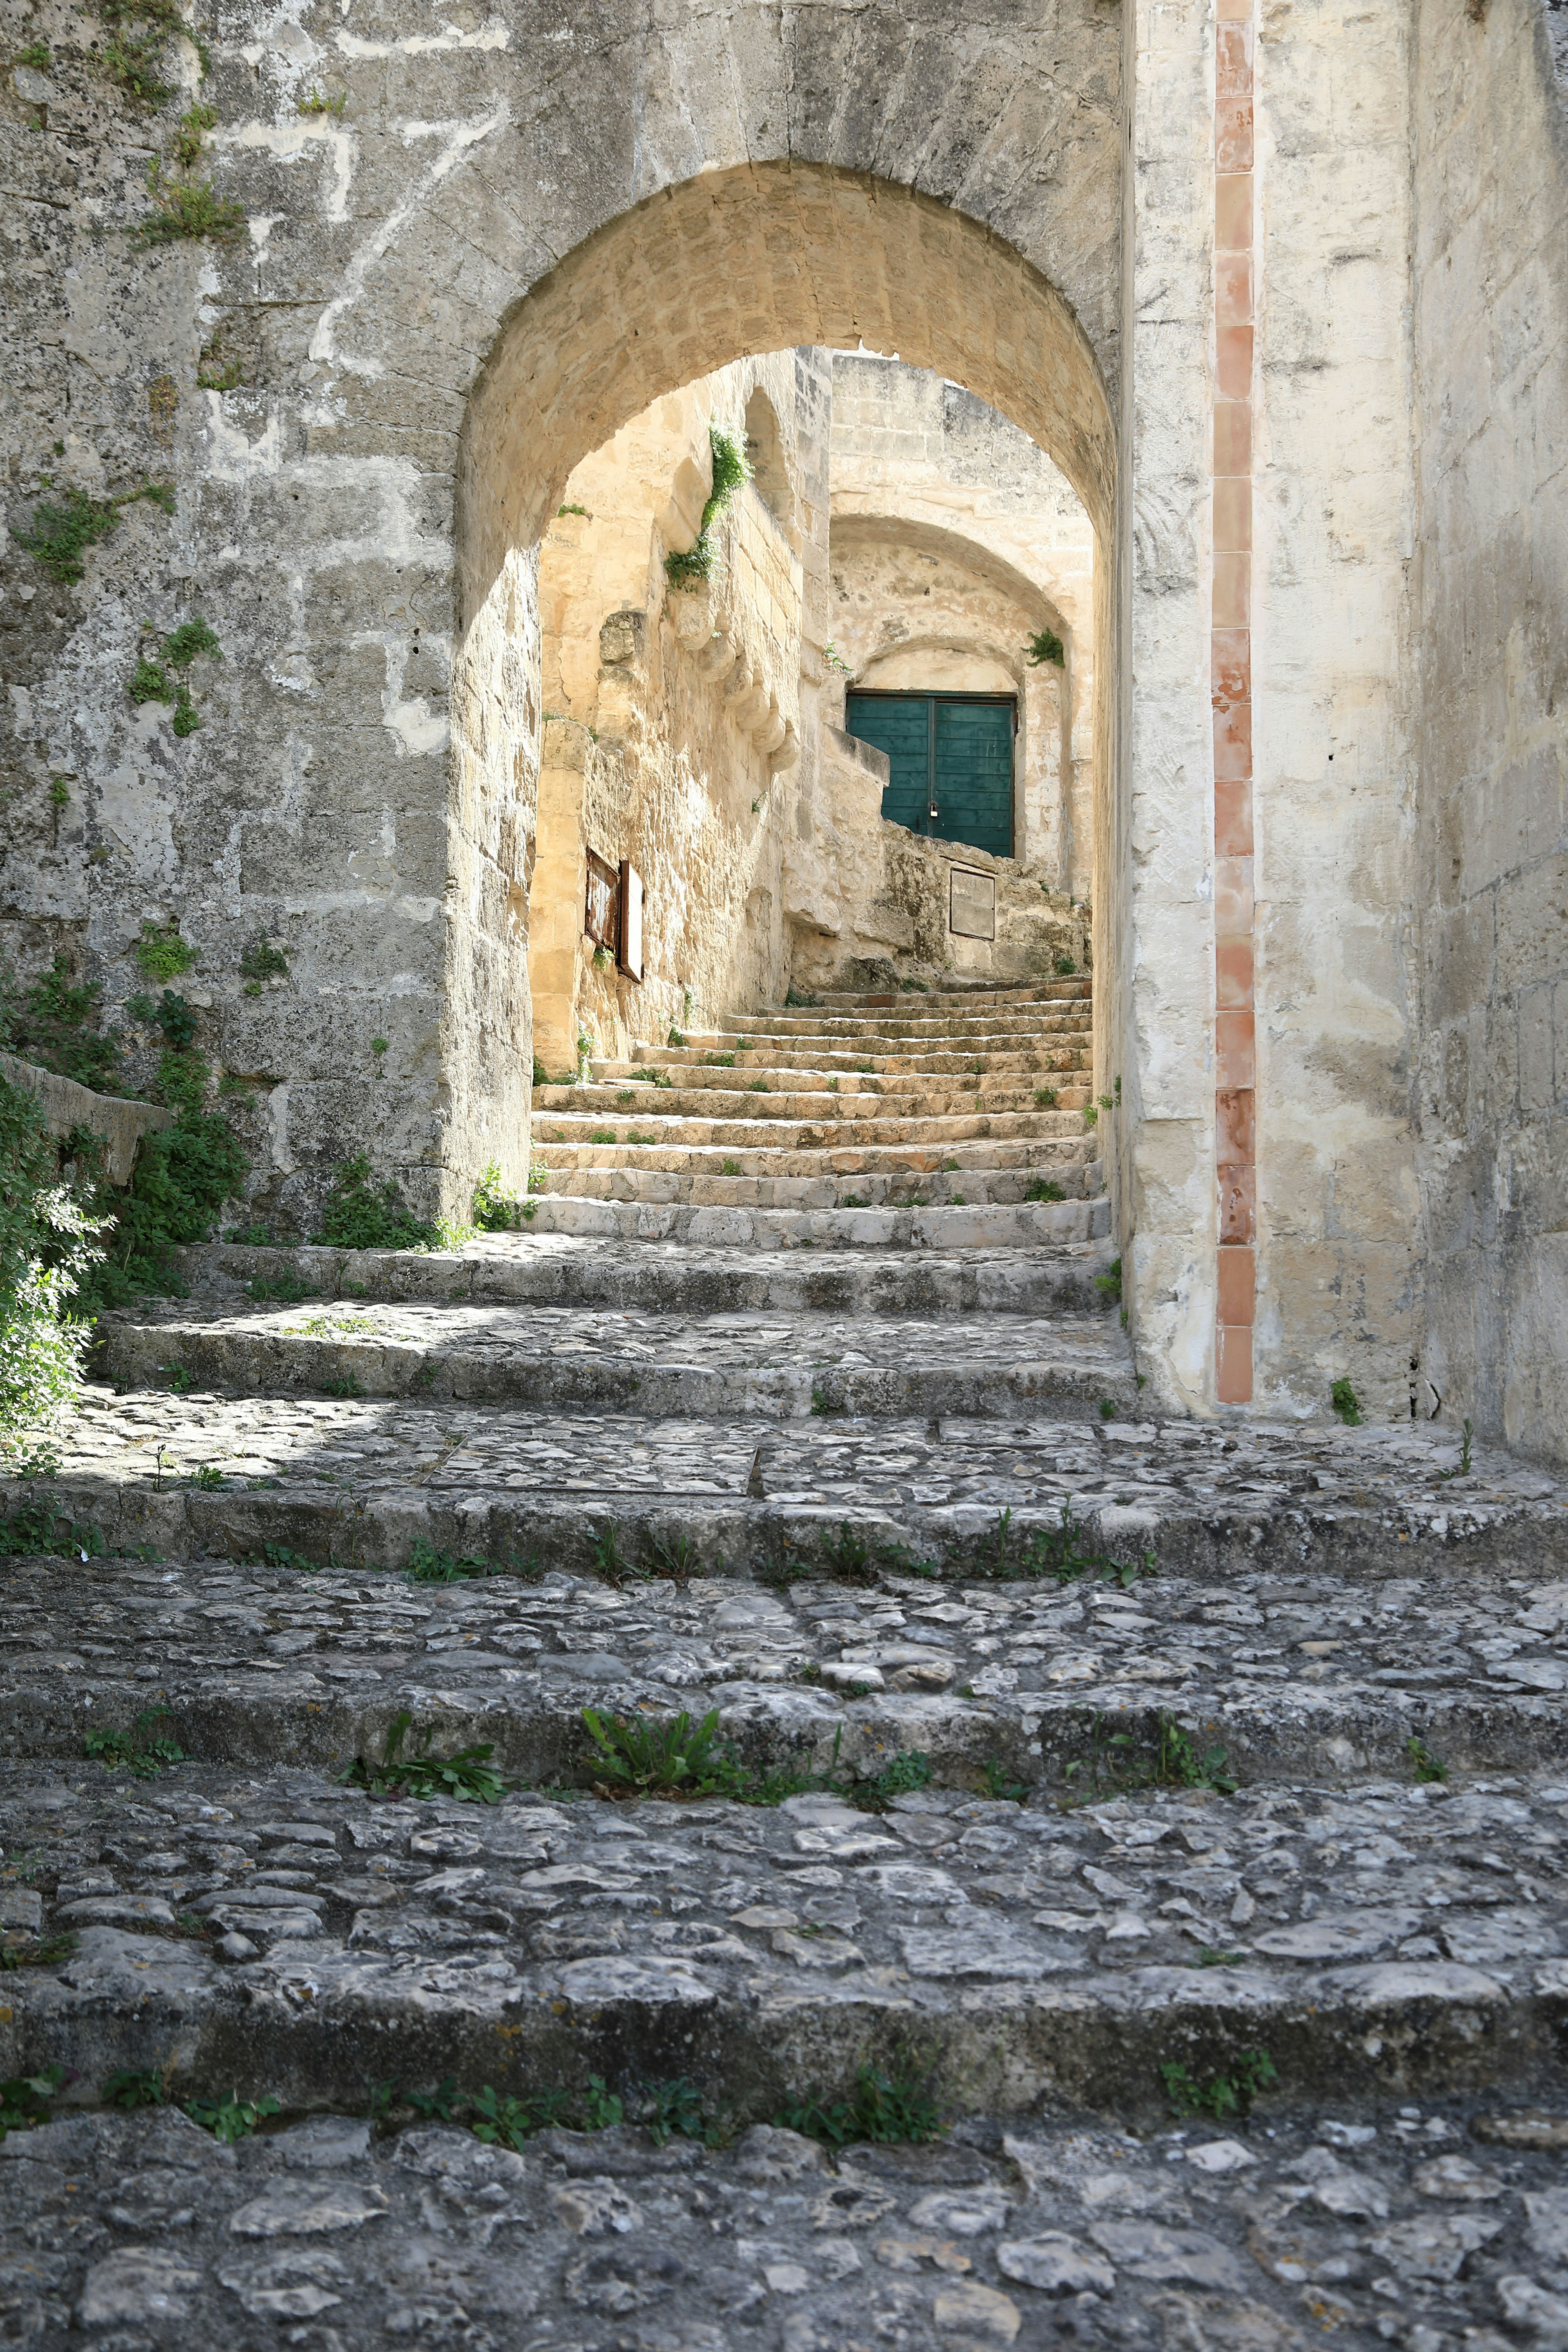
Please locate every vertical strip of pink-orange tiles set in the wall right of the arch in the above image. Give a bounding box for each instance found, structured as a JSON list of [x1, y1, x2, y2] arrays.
[[1211, 0, 1258, 1404]]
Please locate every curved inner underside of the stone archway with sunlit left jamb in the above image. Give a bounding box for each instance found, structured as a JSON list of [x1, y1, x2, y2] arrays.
[[447, 162, 1117, 1204]]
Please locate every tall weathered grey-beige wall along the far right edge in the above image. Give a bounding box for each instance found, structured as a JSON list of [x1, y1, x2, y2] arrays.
[[1415, 0, 1568, 1461]]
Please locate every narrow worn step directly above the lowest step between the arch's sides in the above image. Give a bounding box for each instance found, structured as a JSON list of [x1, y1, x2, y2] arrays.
[[522, 1162, 1100, 1209]]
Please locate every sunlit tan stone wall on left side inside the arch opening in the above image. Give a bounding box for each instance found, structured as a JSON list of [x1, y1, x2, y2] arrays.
[[529, 350, 828, 1075]]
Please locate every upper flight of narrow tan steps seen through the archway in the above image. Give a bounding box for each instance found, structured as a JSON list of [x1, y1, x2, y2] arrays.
[[522, 978, 1109, 1249]]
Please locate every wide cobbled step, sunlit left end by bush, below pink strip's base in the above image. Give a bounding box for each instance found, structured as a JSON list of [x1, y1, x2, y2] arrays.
[[7, 1367, 1568, 1580]]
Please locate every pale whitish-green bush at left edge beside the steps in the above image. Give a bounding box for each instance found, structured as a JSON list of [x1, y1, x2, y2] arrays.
[[0, 1080, 101, 1449]]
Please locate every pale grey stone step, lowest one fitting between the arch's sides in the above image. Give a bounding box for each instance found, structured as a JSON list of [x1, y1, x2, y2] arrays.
[[496, 1195, 1109, 1251]]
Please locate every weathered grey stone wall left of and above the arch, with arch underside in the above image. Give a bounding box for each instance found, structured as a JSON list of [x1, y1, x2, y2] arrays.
[[0, 0, 1121, 1232]]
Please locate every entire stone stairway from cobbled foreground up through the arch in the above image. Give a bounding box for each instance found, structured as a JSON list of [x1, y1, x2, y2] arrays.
[[0, 964, 1568, 2352]]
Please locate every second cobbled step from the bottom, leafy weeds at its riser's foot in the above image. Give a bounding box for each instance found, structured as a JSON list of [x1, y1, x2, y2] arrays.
[[0, 1555, 1568, 1783]]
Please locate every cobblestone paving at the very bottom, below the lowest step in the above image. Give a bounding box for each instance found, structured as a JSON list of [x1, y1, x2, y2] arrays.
[[0, 2105, 1568, 2352]]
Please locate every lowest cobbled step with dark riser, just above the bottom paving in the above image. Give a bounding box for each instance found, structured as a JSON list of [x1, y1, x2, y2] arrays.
[[0, 1740, 1568, 2119]]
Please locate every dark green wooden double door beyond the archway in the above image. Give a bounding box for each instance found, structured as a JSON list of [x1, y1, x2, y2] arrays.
[[844, 694, 1018, 858]]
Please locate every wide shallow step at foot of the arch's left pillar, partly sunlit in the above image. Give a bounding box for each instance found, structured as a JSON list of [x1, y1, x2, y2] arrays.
[[172, 1232, 1128, 1317]]
